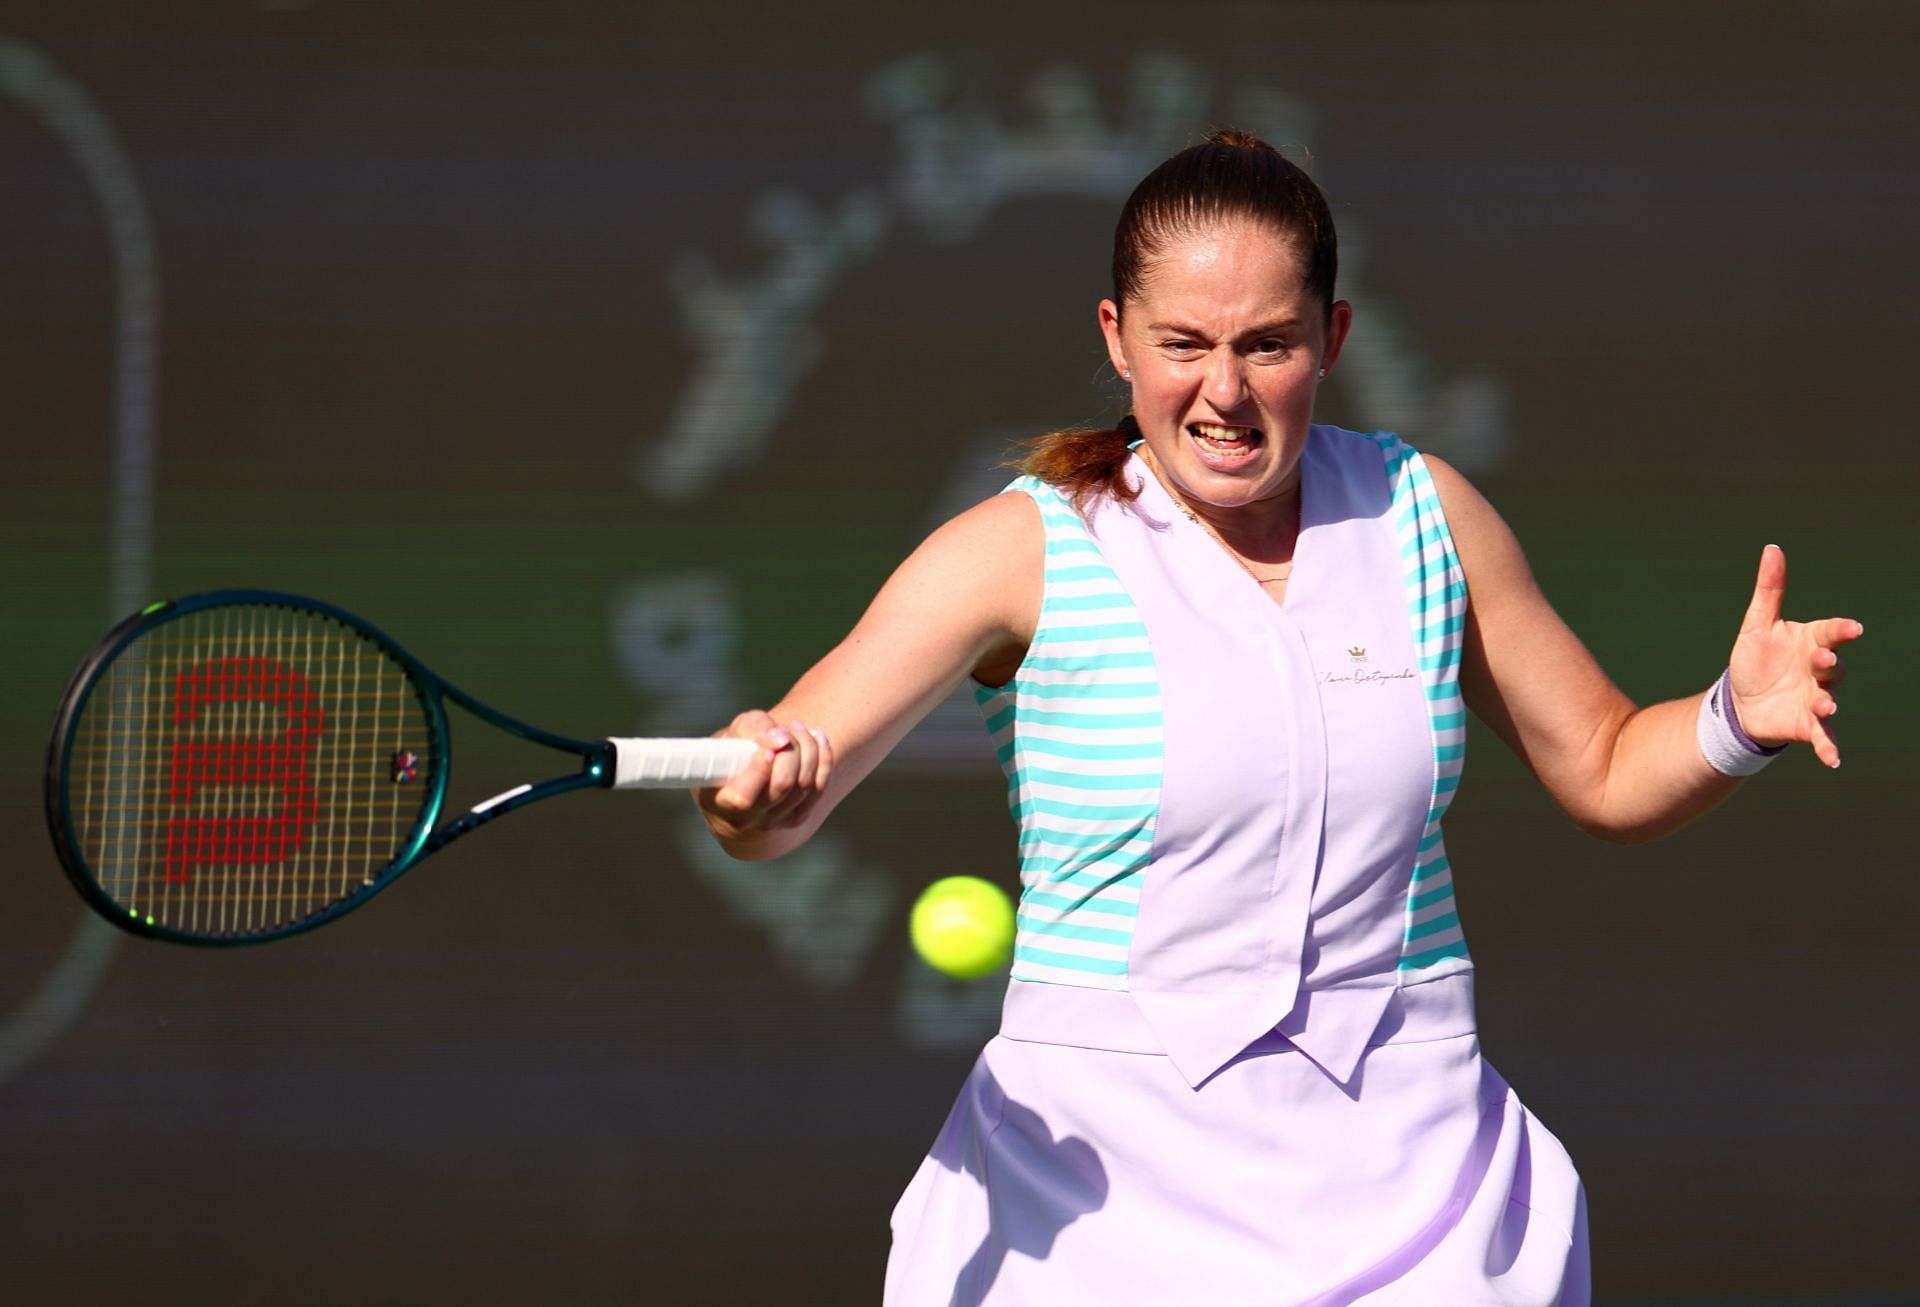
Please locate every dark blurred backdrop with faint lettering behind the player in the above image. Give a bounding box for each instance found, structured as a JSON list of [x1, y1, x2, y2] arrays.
[[0, 0, 1920, 1303]]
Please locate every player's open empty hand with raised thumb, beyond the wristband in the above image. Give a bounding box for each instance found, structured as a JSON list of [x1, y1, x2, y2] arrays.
[[1728, 545, 1866, 768]]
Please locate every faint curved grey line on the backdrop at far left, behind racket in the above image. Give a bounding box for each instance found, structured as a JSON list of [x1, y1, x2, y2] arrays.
[[0, 36, 159, 1082]]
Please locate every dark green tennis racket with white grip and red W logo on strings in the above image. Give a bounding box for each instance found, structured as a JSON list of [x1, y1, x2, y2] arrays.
[[46, 589, 755, 944]]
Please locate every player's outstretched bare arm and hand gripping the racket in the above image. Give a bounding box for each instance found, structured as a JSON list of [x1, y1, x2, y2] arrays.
[[697, 483, 1044, 860]]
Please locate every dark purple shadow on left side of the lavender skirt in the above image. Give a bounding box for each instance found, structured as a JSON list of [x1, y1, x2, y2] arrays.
[[933, 1067, 1108, 1307]]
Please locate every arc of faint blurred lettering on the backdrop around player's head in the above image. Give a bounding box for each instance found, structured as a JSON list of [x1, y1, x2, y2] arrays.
[[634, 54, 1507, 503]]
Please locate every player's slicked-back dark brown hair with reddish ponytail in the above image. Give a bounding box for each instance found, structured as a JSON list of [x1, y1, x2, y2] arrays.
[[1014, 127, 1340, 509]]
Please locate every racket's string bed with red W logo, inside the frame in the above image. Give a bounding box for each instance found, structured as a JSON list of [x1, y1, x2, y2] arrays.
[[67, 605, 440, 937]]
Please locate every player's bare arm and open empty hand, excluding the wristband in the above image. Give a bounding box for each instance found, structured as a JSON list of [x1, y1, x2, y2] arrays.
[[1427, 457, 1862, 841]]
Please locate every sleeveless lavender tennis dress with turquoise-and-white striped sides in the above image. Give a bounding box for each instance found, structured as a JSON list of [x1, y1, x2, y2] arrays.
[[885, 426, 1588, 1307]]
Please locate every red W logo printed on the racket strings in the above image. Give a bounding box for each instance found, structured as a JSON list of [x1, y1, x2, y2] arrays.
[[167, 658, 326, 883]]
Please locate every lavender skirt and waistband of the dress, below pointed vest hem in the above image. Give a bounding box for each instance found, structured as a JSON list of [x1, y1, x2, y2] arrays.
[[885, 990, 1590, 1307]]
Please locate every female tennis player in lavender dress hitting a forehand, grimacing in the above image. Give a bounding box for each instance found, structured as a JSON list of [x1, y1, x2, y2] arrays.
[[699, 132, 1862, 1307]]
